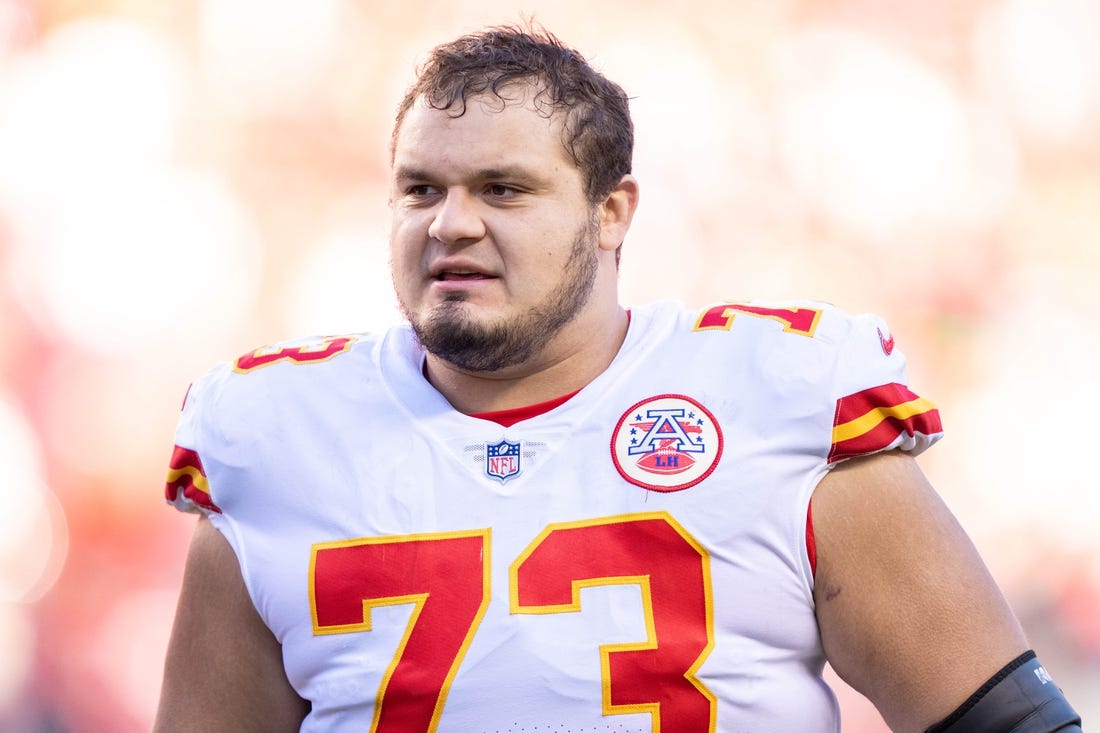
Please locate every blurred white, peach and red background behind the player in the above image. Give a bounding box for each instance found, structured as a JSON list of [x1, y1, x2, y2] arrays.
[[0, 0, 1100, 733]]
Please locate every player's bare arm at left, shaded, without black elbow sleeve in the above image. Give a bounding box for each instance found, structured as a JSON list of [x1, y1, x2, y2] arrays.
[[153, 517, 309, 733]]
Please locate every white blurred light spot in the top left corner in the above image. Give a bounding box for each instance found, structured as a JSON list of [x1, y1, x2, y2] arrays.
[[0, 15, 184, 208]]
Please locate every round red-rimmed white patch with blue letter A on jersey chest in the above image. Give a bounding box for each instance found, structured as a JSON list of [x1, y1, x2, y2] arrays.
[[611, 394, 723, 492]]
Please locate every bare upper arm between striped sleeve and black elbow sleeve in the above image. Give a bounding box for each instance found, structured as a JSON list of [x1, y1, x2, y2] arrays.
[[813, 453, 1027, 733]]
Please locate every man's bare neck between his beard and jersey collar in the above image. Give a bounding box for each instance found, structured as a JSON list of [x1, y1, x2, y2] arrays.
[[425, 306, 629, 415]]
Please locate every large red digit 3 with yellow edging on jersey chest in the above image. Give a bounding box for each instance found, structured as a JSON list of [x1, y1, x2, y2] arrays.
[[509, 512, 717, 733]]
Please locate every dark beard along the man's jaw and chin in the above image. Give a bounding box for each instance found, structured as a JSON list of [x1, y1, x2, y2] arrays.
[[410, 223, 598, 372]]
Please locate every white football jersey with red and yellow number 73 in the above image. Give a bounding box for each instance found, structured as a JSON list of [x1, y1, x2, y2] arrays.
[[166, 303, 941, 733]]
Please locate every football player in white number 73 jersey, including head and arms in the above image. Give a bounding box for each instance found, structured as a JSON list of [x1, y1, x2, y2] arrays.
[[150, 22, 1080, 733]]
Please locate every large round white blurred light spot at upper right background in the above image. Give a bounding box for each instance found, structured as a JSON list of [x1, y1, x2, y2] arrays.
[[776, 29, 1012, 236]]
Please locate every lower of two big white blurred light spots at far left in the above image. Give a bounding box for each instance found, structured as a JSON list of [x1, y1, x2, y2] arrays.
[[12, 169, 261, 355]]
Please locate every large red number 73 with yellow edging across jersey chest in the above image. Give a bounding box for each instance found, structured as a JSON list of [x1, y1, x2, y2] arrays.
[[309, 512, 716, 733]]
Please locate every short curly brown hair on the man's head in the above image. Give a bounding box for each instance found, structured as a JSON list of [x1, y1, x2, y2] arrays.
[[389, 25, 634, 204]]
